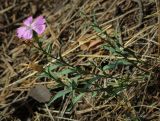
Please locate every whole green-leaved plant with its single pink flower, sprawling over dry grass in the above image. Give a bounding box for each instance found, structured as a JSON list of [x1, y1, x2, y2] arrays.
[[17, 16, 148, 110]]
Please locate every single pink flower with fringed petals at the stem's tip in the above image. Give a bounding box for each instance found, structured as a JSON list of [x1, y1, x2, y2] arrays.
[[17, 16, 46, 39]]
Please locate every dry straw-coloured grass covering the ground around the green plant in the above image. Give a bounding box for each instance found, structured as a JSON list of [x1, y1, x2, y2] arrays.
[[0, 0, 160, 121]]
